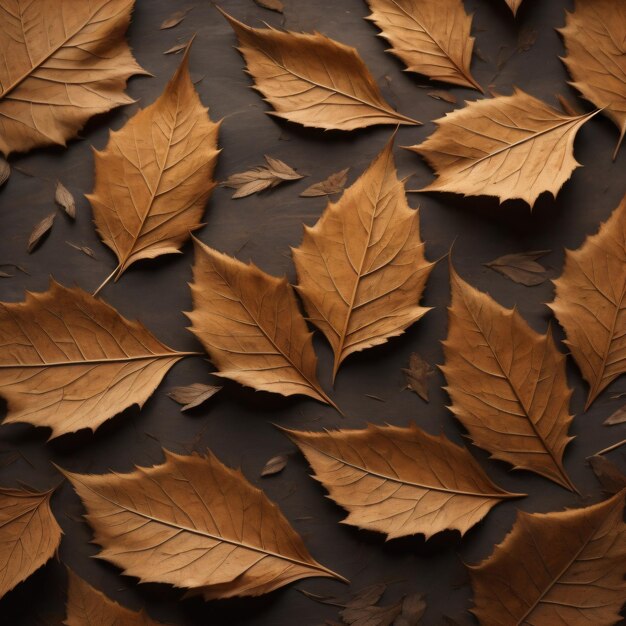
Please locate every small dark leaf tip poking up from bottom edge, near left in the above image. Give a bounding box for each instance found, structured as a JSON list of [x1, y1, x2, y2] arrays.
[[63, 569, 162, 626]]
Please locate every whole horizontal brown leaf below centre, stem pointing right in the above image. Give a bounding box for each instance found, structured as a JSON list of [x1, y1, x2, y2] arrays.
[[284, 424, 521, 539]]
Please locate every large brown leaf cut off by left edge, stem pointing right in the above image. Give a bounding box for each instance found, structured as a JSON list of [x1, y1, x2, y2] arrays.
[[0, 280, 190, 438]]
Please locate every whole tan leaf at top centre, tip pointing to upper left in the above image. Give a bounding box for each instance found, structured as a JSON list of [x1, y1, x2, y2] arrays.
[[217, 7, 420, 130]]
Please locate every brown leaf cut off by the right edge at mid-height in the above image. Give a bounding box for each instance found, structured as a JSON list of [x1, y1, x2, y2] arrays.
[[548, 196, 626, 410]]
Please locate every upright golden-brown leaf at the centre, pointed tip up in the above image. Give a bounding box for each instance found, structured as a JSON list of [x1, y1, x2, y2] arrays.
[[292, 138, 433, 378]]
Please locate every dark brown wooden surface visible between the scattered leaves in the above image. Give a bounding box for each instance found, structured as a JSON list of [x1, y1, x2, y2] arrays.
[[0, 0, 626, 626]]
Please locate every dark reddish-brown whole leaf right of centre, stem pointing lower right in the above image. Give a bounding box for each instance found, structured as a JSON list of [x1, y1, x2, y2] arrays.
[[441, 265, 576, 491]]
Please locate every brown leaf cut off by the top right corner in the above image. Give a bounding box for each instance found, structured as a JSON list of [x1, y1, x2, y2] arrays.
[[558, 0, 626, 158]]
